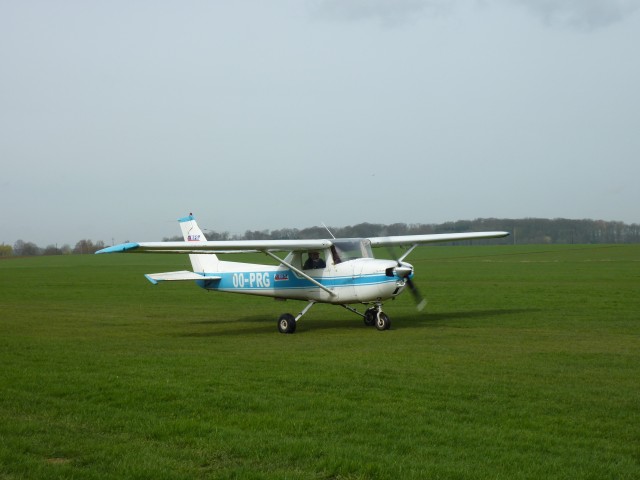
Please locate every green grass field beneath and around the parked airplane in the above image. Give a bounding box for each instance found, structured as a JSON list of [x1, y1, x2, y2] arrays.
[[0, 245, 640, 479]]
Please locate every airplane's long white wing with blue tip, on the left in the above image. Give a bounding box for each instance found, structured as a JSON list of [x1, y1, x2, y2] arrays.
[[96, 240, 333, 253]]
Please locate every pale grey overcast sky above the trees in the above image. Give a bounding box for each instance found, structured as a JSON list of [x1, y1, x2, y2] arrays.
[[0, 0, 640, 247]]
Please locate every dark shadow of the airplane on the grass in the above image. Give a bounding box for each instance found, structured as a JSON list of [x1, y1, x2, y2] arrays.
[[178, 308, 539, 337]]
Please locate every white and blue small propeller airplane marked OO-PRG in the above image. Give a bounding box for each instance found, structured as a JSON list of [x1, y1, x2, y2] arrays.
[[96, 214, 509, 333]]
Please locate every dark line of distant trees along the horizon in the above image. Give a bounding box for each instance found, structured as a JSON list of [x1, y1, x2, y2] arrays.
[[0, 218, 640, 257]]
